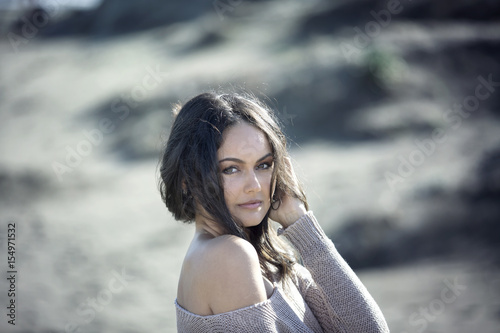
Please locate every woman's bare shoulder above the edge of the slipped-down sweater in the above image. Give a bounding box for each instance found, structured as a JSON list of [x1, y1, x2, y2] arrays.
[[181, 235, 267, 314]]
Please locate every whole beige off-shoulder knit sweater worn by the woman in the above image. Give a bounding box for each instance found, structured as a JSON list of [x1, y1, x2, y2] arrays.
[[175, 211, 389, 333]]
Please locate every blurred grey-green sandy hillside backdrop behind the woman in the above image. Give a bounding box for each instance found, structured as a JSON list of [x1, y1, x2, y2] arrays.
[[0, 0, 500, 333]]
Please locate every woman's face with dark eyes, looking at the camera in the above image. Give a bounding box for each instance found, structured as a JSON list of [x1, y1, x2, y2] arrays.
[[217, 122, 274, 227]]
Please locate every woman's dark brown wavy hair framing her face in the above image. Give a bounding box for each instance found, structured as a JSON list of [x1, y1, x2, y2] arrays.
[[159, 92, 308, 279]]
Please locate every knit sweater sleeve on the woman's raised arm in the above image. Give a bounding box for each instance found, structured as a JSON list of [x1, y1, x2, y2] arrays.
[[280, 211, 389, 333]]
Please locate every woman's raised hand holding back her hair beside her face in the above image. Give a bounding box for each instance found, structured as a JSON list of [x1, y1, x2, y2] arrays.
[[269, 157, 307, 228]]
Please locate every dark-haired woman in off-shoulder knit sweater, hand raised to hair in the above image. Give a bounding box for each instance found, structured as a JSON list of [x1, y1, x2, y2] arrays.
[[160, 93, 389, 333]]
